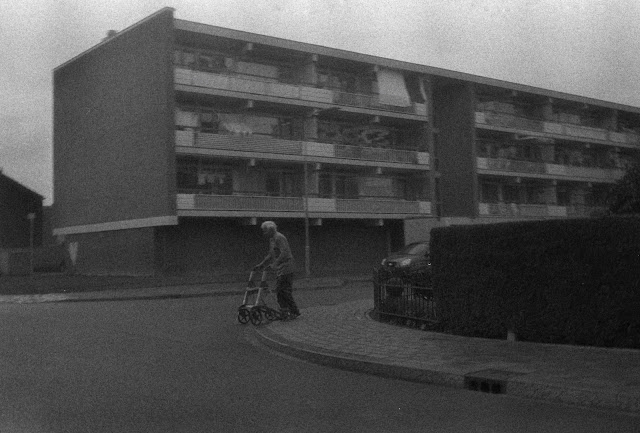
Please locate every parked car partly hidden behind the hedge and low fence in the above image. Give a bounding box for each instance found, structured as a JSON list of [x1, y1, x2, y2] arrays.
[[373, 242, 431, 295]]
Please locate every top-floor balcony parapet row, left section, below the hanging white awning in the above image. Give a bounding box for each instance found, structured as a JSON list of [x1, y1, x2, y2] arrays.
[[174, 67, 427, 117]]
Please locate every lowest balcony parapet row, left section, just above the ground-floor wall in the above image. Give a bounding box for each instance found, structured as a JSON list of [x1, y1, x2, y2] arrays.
[[177, 193, 431, 218]]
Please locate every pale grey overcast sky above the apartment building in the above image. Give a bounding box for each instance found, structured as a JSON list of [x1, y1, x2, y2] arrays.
[[0, 0, 640, 204]]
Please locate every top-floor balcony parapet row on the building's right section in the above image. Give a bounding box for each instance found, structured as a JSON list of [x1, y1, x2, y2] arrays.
[[475, 111, 640, 147]]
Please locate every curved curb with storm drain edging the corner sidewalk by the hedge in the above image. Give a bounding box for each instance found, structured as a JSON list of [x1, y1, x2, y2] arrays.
[[255, 318, 640, 415]]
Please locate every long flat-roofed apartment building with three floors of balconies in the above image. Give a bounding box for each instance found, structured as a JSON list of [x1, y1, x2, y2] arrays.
[[54, 8, 640, 274]]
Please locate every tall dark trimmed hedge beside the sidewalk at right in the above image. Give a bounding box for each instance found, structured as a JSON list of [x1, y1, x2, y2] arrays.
[[431, 217, 640, 349]]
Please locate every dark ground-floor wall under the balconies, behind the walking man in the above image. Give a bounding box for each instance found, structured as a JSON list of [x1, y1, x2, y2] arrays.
[[156, 218, 403, 278]]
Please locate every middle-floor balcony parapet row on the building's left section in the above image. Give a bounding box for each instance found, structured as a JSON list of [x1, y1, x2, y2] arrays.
[[176, 130, 429, 169]]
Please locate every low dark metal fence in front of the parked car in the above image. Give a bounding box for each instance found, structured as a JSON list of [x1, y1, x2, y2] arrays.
[[373, 279, 438, 326]]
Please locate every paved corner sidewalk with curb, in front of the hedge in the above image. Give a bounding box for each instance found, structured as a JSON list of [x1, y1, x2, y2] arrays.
[[255, 300, 640, 415]]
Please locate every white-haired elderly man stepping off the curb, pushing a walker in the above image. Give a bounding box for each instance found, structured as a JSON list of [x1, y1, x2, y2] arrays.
[[254, 221, 300, 319]]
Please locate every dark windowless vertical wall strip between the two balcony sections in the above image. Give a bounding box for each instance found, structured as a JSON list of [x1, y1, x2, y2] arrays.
[[433, 81, 478, 218]]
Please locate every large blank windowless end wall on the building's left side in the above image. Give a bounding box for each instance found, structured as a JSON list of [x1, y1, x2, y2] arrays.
[[53, 9, 176, 228]]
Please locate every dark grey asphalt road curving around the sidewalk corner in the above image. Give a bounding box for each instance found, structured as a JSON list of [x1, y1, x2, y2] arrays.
[[0, 285, 640, 433]]
